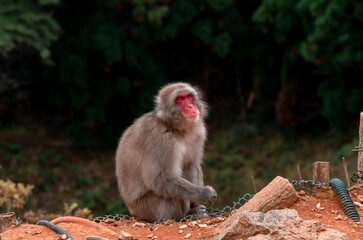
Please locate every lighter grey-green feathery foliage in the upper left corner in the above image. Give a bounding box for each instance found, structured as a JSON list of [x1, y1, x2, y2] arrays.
[[0, 0, 60, 60]]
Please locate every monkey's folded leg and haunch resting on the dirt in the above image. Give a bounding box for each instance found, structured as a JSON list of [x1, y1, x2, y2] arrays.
[[128, 192, 190, 222]]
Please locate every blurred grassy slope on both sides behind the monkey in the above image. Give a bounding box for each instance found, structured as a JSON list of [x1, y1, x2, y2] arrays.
[[0, 124, 358, 215]]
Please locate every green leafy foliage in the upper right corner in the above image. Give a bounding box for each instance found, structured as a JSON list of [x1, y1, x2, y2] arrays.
[[254, 0, 363, 130]]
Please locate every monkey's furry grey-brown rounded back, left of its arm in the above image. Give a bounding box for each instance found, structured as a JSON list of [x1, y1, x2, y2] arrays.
[[116, 112, 173, 205]]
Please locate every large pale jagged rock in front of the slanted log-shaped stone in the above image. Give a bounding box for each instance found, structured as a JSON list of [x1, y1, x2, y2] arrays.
[[212, 209, 348, 240]]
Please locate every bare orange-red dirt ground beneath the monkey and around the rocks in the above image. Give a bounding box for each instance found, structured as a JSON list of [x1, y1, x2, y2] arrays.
[[1, 189, 363, 240]]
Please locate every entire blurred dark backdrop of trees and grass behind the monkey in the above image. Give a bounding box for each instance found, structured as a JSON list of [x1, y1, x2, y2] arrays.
[[0, 0, 363, 217]]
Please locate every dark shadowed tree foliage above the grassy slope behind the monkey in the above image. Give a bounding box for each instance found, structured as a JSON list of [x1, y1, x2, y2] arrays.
[[0, 0, 363, 144]]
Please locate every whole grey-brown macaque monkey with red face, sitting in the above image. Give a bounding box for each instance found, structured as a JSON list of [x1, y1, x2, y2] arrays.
[[116, 83, 217, 222]]
